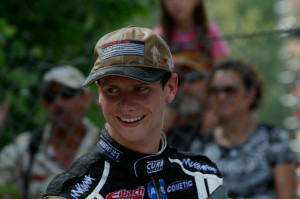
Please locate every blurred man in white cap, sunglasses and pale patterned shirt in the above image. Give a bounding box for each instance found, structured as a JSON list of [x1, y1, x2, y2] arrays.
[[0, 66, 99, 199]]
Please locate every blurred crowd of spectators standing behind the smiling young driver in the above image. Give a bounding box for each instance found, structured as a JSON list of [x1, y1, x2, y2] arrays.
[[0, 0, 299, 199]]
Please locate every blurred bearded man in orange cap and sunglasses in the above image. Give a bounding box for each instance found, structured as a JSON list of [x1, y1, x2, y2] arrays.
[[164, 53, 215, 152]]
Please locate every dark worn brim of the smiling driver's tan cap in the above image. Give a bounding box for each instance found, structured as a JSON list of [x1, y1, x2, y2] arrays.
[[82, 66, 170, 87]]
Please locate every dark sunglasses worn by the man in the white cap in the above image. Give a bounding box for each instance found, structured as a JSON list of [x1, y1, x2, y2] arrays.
[[42, 87, 82, 102]]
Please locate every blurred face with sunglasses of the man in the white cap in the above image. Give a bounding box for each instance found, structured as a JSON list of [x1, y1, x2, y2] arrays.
[[42, 82, 91, 127]]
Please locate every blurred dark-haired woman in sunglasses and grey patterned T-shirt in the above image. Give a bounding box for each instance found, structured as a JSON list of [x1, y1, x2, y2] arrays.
[[198, 60, 299, 199]]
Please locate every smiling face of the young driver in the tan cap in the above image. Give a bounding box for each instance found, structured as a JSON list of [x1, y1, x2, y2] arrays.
[[97, 74, 177, 149]]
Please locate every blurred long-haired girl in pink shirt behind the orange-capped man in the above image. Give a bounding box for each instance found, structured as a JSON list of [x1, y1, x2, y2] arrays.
[[154, 0, 229, 68]]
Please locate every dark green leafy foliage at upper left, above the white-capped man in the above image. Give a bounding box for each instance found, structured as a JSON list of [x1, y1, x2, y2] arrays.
[[0, 0, 155, 148]]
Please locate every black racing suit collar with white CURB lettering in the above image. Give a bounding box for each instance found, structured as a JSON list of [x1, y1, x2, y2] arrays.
[[97, 128, 169, 178]]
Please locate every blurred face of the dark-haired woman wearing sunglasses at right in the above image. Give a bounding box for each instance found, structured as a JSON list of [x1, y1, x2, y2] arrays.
[[210, 70, 253, 119]]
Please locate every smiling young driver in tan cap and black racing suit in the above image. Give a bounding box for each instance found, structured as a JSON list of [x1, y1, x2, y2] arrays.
[[44, 27, 226, 199]]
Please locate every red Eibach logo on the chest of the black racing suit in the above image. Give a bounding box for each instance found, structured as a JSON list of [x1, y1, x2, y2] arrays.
[[105, 187, 145, 199]]
